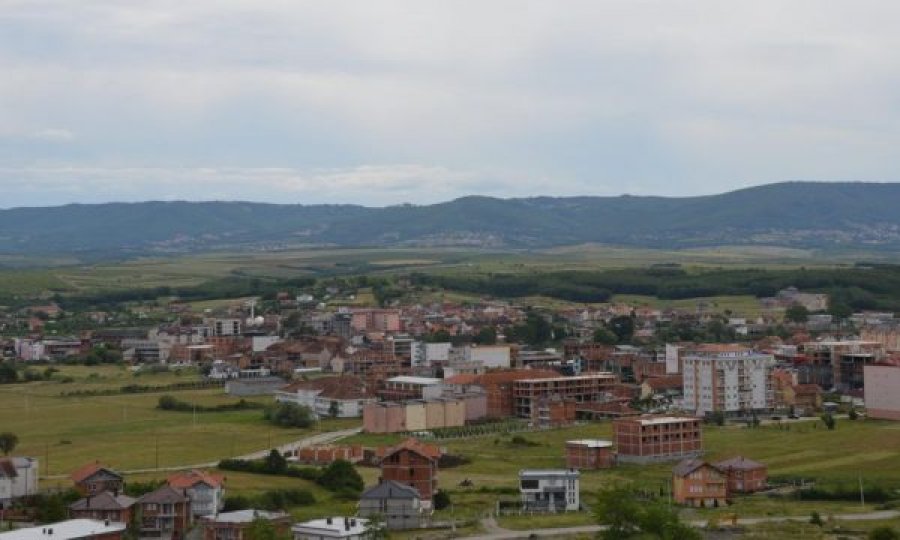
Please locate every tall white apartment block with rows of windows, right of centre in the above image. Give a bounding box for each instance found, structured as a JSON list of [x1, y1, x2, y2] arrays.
[[683, 344, 775, 416]]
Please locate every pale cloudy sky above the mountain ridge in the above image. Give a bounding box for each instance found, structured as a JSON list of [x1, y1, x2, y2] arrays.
[[0, 0, 900, 208]]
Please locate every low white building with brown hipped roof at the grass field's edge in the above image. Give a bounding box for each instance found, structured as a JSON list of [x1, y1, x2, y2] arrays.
[[275, 375, 375, 418]]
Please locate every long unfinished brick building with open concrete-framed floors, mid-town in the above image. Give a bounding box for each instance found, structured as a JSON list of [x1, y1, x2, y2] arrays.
[[513, 373, 616, 418]]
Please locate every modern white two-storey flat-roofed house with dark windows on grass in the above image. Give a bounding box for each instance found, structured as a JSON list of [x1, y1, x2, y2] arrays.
[[519, 469, 581, 512]]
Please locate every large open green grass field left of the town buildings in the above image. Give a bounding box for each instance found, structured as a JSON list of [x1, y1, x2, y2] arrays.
[[0, 366, 356, 485]]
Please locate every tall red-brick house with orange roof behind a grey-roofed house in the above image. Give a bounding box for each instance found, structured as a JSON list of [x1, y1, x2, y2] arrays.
[[379, 438, 441, 509]]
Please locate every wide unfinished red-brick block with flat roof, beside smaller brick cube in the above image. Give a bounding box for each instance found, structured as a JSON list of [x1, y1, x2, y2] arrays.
[[613, 416, 703, 463]]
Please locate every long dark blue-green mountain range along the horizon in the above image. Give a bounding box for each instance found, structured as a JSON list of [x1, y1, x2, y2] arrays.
[[0, 182, 900, 256]]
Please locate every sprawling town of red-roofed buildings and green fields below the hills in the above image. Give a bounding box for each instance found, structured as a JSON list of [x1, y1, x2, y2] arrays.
[[0, 275, 900, 540]]
